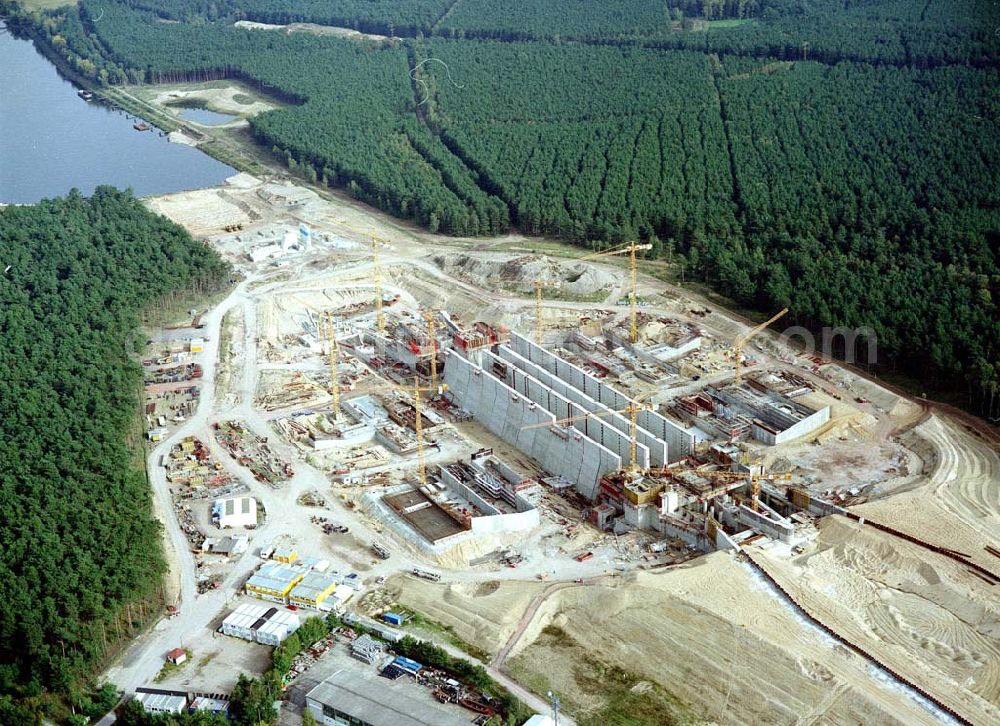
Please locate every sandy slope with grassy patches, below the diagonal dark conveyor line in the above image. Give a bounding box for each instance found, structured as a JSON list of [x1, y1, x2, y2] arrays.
[[394, 553, 952, 724]]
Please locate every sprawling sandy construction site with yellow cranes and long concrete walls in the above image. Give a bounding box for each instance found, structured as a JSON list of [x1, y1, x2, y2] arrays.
[[112, 175, 1000, 724]]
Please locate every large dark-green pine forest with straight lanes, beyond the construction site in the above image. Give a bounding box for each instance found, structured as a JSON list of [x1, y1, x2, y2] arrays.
[[15, 0, 1000, 415]]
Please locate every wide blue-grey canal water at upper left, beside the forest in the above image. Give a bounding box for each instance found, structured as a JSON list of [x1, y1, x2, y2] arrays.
[[0, 21, 236, 204]]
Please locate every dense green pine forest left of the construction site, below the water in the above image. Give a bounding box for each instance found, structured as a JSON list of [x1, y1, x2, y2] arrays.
[[0, 187, 229, 724]]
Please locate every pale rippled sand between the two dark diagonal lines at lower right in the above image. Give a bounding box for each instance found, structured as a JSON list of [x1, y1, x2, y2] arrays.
[[751, 517, 1000, 723]]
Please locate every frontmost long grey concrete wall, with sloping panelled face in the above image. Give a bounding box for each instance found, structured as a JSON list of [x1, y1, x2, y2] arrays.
[[444, 351, 622, 499]]
